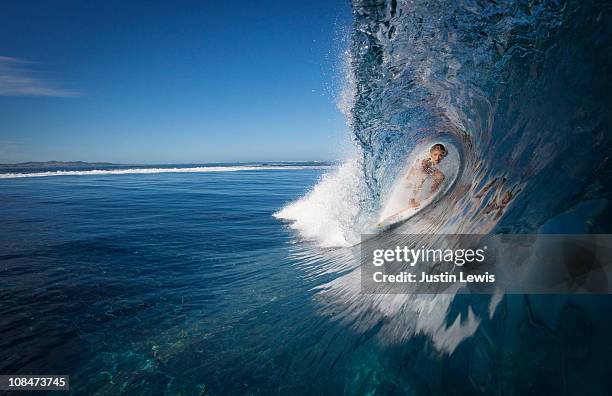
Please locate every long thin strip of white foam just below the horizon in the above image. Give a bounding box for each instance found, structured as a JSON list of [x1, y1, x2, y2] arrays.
[[0, 165, 333, 179]]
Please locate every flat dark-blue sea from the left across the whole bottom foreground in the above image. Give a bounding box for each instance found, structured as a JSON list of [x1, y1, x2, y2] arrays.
[[0, 169, 612, 395]]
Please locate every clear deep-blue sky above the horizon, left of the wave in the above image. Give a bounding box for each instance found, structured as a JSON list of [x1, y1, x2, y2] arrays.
[[0, 0, 351, 163]]
